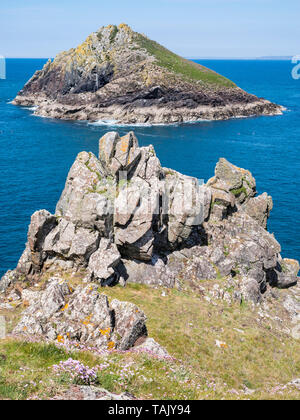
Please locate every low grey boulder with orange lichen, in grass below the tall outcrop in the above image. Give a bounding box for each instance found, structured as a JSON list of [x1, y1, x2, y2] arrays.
[[14, 278, 147, 351]]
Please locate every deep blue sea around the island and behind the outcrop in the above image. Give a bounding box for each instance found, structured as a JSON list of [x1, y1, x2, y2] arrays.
[[0, 59, 300, 275]]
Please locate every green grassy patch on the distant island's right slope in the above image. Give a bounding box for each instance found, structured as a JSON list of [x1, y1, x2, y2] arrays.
[[134, 33, 236, 87]]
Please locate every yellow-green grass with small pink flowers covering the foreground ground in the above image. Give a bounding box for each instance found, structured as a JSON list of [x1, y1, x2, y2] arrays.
[[0, 279, 300, 399]]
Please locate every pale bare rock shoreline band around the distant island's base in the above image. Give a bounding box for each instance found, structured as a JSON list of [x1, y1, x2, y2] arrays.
[[12, 96, 285, 125]]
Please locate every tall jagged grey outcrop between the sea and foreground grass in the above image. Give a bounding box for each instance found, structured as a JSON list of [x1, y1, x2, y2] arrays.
[[0, 132, 299, 312]]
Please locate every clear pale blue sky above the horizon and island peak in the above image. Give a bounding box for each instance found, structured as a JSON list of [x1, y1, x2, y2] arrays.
[[0, 0, 300, 58]]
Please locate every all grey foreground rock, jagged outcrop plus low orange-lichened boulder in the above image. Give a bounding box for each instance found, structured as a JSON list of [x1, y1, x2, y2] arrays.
[[0, 132, 300, 354]]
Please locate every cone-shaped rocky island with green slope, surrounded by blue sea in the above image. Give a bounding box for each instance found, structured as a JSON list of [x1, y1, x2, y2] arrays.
[[14, 24, 283, 124]]
